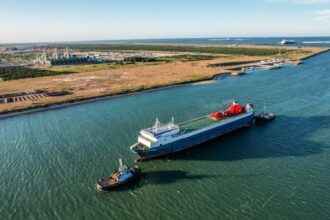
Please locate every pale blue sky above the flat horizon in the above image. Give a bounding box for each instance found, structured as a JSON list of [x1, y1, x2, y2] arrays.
[[0, 0, 330, 43]]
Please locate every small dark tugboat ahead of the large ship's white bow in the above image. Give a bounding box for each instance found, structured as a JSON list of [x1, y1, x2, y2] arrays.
[[96, 159, 141, 191]]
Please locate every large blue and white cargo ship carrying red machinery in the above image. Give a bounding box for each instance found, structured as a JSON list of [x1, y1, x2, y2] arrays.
[[130, 102, 254, 160]]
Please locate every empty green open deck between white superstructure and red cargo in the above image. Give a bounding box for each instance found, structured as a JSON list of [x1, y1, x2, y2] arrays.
[[179, 116, 226, 133]]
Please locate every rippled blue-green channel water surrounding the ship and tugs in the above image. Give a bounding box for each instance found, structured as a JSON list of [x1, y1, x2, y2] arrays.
[[0, 53, 330, 219]]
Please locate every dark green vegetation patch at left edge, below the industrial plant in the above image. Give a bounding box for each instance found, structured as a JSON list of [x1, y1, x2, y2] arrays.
[[0, 67, 75, 81]]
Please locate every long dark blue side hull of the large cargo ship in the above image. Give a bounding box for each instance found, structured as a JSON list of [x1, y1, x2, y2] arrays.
[[135, 114, 254, 159]]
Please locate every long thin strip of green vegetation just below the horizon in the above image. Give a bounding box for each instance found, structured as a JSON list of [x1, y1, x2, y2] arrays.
[[49, 44, 293, 56]]
